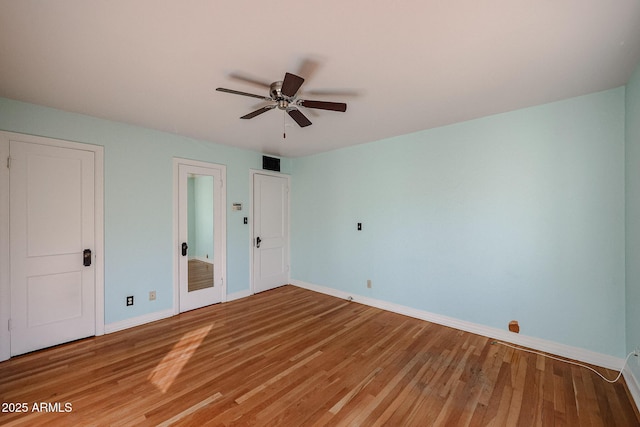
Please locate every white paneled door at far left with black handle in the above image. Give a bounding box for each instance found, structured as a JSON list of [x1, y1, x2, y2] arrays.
[[9, 141, 96, 356]]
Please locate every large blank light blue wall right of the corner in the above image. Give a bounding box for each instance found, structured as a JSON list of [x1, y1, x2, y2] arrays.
[[291, 88, 625, 356]]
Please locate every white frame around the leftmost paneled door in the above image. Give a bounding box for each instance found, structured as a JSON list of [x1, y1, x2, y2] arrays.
[[0, 131, 104, 361]]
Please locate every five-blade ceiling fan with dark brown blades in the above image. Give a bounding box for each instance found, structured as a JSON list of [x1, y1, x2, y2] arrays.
[[216, 73, 347, 127]]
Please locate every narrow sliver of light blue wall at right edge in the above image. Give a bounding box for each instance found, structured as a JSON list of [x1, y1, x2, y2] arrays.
[[626, 60, 640, 383]]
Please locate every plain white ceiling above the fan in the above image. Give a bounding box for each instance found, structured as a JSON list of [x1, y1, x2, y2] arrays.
[[0, 0, 640, 157]]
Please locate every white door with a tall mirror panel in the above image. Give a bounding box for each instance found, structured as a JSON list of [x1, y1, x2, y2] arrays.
[[176, 162, 226, 312]]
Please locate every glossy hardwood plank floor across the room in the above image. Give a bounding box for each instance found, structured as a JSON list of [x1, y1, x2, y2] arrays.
[[0, 286, 640, 426]]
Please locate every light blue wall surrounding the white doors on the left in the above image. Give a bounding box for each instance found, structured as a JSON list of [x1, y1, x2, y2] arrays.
[[0, 98, 290, 324]]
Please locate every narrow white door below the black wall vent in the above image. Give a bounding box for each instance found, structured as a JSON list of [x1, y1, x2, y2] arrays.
[[252, 173, 289, 293]]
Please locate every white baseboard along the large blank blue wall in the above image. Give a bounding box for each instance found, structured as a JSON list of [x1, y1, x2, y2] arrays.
[[291, 280, 624, 370]]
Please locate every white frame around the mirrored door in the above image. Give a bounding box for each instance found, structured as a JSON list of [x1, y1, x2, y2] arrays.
[[173, 157, 227, 315]]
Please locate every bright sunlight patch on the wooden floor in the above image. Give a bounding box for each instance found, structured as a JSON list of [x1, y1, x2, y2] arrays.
[[149, 325, 213, 393]]
